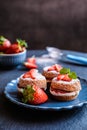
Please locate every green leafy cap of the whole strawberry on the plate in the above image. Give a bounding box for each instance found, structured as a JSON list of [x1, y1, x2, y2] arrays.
[[22, 85, 35, 103]]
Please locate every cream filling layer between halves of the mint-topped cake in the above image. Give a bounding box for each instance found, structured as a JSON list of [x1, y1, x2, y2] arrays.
[[50, 89, 79, 96]]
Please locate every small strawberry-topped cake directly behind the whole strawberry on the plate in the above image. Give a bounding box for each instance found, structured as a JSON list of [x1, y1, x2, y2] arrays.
[[18, 69, 47, 92]]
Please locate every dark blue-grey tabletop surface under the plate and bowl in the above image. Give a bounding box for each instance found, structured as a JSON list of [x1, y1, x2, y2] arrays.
[[0, 50, 87, 130]]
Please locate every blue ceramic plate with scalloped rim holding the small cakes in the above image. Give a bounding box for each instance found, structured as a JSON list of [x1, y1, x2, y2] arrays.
[[4, 79, 87, 111]]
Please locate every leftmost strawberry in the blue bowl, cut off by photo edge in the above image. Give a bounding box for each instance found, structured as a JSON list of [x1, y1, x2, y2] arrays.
[[0, 36, 11, 52]]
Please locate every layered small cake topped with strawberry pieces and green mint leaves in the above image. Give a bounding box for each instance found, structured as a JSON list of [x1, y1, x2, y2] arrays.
[[50, 68, 81, 101]]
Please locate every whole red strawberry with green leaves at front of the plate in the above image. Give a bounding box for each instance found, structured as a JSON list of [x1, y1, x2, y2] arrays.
[[22, 85, 48, 105]]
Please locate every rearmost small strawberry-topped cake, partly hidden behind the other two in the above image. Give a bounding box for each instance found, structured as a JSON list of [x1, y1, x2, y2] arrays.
[[42, 64, 62, 82]]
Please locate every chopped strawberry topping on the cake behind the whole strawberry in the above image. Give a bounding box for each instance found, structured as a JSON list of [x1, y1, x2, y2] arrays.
[[23, 69, 38, 79]]
